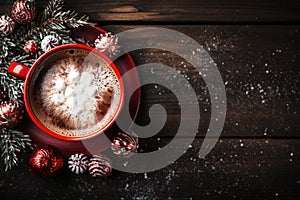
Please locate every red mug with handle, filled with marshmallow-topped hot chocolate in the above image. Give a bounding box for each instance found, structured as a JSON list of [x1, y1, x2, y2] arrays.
[[8, 44, 124, 141]]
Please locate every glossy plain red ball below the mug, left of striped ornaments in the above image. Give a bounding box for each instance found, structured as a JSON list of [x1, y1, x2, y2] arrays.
[[29, 145, 64, 178]]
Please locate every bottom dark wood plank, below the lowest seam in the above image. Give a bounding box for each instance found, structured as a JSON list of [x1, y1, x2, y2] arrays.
[[0, 139, 300, 199]]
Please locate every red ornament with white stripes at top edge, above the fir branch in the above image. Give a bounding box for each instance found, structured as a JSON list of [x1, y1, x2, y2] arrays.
[[11, 0, 36, 24]]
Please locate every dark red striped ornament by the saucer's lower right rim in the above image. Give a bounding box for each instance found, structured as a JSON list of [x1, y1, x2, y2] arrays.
[[111, 132, 138, 157]]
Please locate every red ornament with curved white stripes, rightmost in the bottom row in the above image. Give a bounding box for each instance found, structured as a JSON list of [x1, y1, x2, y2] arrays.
[[89, 155, 112, 178]]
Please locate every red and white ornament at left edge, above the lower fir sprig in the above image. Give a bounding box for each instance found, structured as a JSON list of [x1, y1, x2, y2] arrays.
[[0, 101, 24, 127]]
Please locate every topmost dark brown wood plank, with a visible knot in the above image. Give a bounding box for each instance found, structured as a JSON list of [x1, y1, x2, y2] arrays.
[[0, 0, 300, 23]]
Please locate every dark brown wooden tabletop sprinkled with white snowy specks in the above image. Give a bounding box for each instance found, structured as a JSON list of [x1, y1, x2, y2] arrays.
[[0, 0, 300, 199]]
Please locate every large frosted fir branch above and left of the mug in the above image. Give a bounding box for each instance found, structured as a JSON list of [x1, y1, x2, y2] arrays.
[[0, 0, 88, 101]]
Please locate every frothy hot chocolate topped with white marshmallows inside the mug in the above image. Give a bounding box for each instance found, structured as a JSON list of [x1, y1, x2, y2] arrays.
[[29, 49, 120, 137]]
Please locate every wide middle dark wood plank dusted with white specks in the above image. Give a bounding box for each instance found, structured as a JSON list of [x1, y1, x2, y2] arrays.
[[104, 25, 300, 137]]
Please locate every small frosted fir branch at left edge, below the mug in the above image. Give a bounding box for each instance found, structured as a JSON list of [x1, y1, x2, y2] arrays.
[[0, 128, 31, 171]]
